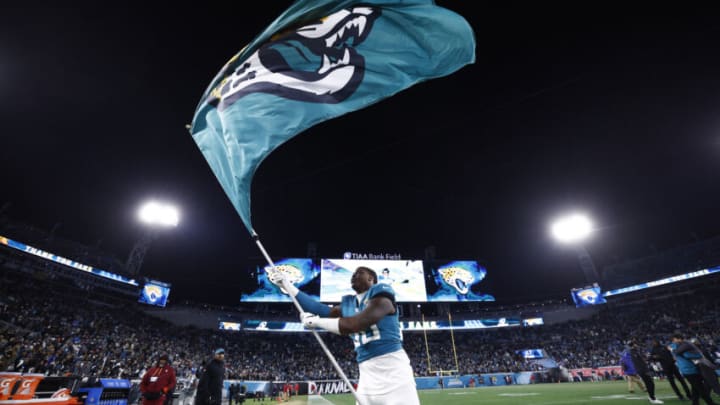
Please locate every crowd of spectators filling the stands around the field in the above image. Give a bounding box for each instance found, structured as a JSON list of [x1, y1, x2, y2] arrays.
[[0, 271, 720, 380]]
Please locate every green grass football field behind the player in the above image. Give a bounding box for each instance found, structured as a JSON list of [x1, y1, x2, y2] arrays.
[[287, 381, 720, 405]]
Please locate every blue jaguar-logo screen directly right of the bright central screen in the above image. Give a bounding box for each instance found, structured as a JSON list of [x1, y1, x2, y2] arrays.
[[426, 260, 495, 302]]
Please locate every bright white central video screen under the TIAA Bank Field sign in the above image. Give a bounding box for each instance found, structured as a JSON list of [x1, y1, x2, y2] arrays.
[[320, 259, 427, 302]]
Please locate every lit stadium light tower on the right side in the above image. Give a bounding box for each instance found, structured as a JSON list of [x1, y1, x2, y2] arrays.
[[550, 213, 599, 283]]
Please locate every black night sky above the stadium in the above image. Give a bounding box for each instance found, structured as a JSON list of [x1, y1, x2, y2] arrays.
[[0, 1, 720, 304]]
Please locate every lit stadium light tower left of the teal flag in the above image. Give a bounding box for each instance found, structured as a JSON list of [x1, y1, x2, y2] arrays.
[[125, 201, 180, 276]]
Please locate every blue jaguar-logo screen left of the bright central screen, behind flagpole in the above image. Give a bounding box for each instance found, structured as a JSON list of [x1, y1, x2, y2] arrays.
[[240, 258, 320, 302]]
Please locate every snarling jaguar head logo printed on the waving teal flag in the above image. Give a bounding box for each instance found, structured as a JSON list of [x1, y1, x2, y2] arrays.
[[208, 7, 380, 111]]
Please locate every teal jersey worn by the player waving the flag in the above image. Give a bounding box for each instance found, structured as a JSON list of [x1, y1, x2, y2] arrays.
[[340, 283, 402, 363]]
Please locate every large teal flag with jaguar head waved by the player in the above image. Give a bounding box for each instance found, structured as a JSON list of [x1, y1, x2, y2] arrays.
[[191, 0, 475, 235]]
